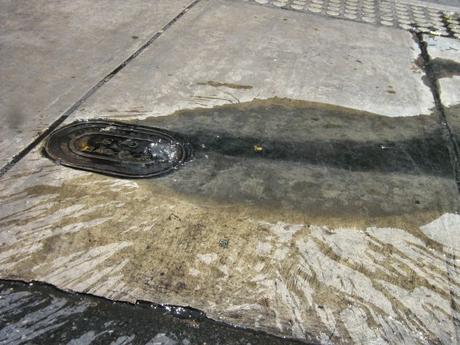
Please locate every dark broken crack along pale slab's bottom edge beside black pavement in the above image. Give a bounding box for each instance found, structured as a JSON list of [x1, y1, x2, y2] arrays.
[[0, 278, 320, 345]]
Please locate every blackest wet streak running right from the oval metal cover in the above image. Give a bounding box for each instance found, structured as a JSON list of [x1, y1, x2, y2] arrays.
[[176, 118, 452, 177]]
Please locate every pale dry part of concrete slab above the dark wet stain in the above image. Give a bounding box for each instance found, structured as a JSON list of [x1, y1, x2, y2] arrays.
[[74, 1, 433, 118]]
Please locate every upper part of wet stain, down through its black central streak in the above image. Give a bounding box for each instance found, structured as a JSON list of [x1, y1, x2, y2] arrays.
[[138, 99, 452, 177]]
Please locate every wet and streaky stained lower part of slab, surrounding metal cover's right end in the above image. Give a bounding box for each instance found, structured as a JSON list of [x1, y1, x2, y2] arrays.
[[0, 99, 460, 344]]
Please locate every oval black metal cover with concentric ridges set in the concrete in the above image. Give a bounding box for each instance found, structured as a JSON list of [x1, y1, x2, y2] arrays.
[[45, 120, 191, 178]]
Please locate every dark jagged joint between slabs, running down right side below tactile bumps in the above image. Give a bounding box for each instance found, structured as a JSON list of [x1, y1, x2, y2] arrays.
[[414, 33, 460, 192]]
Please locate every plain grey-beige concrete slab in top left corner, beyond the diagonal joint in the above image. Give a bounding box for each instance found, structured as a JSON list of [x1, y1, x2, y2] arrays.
[[0, 0, 191, 167]]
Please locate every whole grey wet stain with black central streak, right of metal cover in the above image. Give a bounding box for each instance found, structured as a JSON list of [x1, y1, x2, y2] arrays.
[[120, 98, 458, 225]]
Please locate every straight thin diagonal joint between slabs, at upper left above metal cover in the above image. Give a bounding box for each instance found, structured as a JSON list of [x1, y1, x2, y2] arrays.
[[0, 0, 201, 177]]
